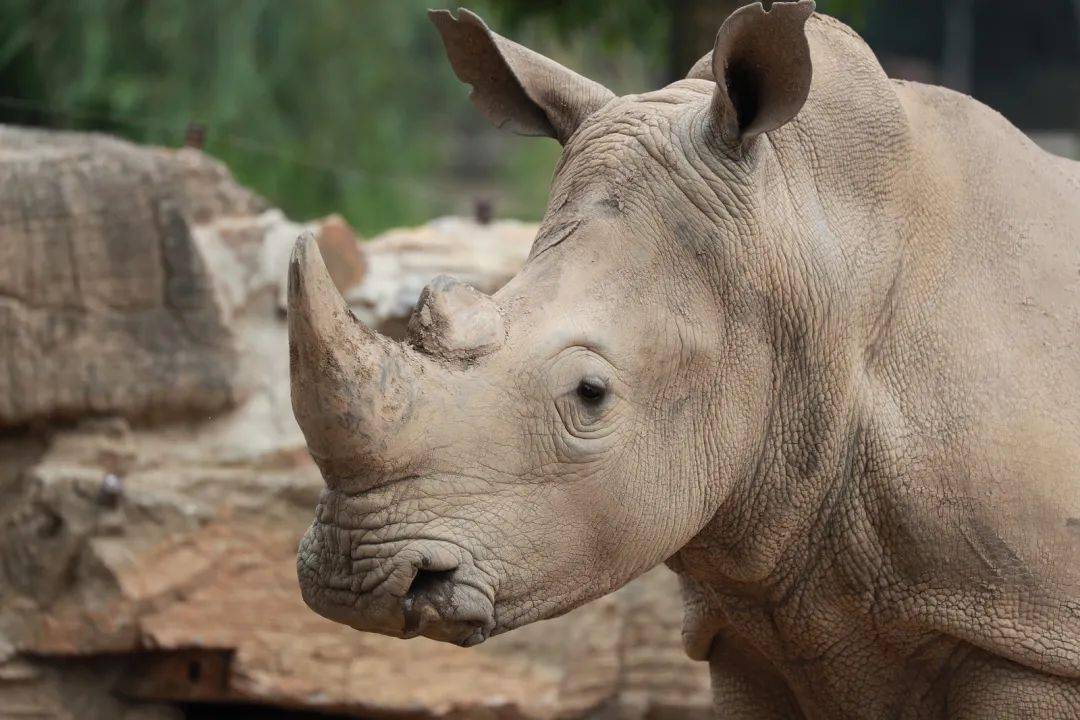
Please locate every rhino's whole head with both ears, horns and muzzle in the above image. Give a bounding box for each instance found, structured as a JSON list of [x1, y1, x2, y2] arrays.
[[288, 1, 813, 646]]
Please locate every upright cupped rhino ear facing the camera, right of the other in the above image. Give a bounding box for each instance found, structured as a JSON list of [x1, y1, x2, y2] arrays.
[[708, 0, 814, 144]]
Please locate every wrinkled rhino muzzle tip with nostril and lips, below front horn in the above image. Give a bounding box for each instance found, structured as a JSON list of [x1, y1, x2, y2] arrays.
[[297, 491, 496, 647]]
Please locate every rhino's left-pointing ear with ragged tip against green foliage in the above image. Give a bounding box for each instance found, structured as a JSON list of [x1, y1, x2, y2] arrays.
[[428, 9, 615, 145]]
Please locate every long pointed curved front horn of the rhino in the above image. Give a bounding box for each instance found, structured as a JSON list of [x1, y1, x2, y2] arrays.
[[288, 233, 416, 474]]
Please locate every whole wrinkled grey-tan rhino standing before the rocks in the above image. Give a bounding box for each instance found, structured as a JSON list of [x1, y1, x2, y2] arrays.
[[289, 2, 1080, 718]]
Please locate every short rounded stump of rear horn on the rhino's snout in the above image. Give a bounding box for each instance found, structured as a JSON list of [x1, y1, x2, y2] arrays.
[[408, 275, 507, 362]]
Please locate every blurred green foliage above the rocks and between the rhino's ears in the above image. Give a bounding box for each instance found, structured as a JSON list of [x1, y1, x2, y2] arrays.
[[0, 0, 868, 234]]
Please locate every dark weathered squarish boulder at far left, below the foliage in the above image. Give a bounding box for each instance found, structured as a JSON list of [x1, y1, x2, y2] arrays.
[[0, 127, 261, 427]]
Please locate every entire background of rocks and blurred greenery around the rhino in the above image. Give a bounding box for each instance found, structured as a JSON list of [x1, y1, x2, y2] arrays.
[[0, 0, 1080, 720]]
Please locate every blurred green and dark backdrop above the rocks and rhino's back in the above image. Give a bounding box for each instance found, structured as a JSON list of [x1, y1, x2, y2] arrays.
[[0, 0, 1080, 235]]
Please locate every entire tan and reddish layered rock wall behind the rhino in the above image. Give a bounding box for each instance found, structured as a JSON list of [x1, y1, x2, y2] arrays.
[[0, 130, 710, 720]]
